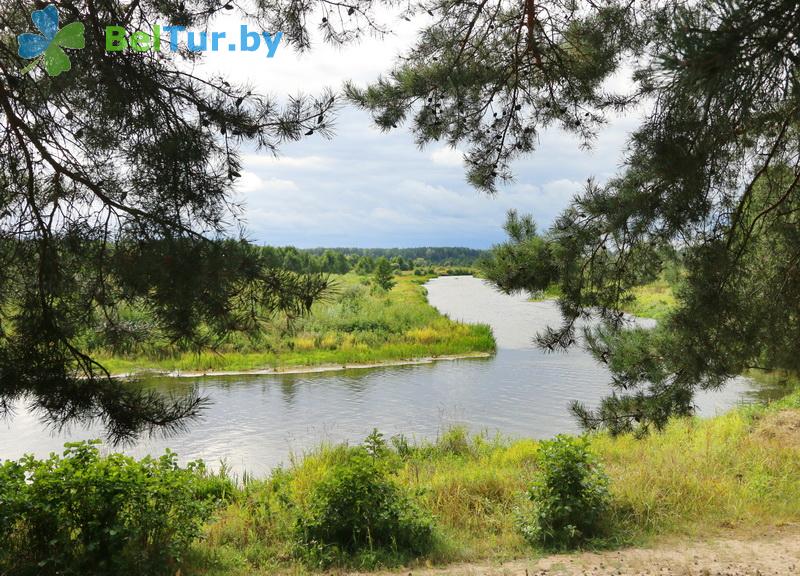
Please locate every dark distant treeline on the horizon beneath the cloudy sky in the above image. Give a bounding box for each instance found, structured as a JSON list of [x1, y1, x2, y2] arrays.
[[261, 246, 485, 274]]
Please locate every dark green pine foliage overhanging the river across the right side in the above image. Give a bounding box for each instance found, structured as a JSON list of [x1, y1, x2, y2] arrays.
[[347, 0, 800, 431]]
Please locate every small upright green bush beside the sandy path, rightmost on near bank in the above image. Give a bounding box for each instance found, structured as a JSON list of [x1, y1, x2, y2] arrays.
[[520, 435, 610, 548]]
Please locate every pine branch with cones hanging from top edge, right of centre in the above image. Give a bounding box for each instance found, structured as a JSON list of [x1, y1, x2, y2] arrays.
[[346, 0, 642, 192]]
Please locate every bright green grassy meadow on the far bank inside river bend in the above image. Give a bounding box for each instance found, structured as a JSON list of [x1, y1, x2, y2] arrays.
[[93, 274, 495, 374]]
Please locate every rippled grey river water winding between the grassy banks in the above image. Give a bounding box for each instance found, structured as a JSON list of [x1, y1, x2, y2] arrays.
[[0, 276, 750, 474]]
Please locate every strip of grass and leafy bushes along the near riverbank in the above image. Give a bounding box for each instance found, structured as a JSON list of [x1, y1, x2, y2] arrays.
[[0, 380, 800, 576]]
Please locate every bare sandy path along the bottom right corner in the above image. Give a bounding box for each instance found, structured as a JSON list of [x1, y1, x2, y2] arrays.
[[356, 526, 800, 576]]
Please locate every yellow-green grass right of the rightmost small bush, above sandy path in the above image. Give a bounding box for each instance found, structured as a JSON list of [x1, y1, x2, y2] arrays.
[[593, 393, 800, 536]]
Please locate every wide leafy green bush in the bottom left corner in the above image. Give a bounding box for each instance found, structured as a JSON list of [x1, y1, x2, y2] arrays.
[[0, 442, 233, 575]]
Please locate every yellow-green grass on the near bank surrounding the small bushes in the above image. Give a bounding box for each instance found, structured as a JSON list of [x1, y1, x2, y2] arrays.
[[190, 382, 800, 576]]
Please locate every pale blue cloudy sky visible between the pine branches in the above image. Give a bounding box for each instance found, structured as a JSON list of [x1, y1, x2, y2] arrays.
[[197, 10, 636, 248]]
